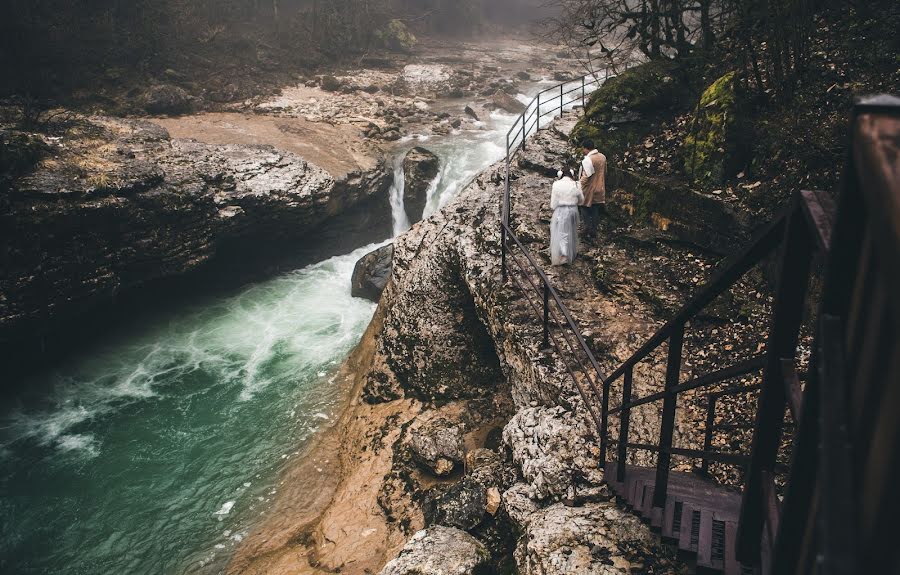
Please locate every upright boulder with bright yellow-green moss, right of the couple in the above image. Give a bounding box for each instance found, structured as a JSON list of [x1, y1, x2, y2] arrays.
[[681, 72, 749, 191]]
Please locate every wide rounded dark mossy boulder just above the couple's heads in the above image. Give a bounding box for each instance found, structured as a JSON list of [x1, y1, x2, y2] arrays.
[[571, 60, 690, 160]]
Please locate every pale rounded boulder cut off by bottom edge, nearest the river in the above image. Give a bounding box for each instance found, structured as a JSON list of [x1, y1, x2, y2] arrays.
[[381, 525, 490, 575]]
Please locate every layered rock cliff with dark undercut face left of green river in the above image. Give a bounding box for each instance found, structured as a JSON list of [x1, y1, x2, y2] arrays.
[[0, 118, 390, 374]]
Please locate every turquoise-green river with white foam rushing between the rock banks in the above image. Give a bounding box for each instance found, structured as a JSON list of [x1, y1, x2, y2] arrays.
[[0, 98, 548, 574]]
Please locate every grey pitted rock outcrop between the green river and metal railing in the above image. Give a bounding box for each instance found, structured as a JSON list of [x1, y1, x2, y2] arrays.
[[344, 116, 677, 575]]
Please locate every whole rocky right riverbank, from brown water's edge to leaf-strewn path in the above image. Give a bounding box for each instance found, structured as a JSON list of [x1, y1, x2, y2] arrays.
[[232, 82, 784, 575]]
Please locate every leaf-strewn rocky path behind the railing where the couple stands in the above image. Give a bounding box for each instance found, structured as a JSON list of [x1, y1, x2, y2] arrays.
[[512, 114, 771, 481]]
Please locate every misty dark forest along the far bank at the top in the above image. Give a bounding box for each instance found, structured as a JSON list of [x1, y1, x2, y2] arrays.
[[0, 0, 550, 98]]
